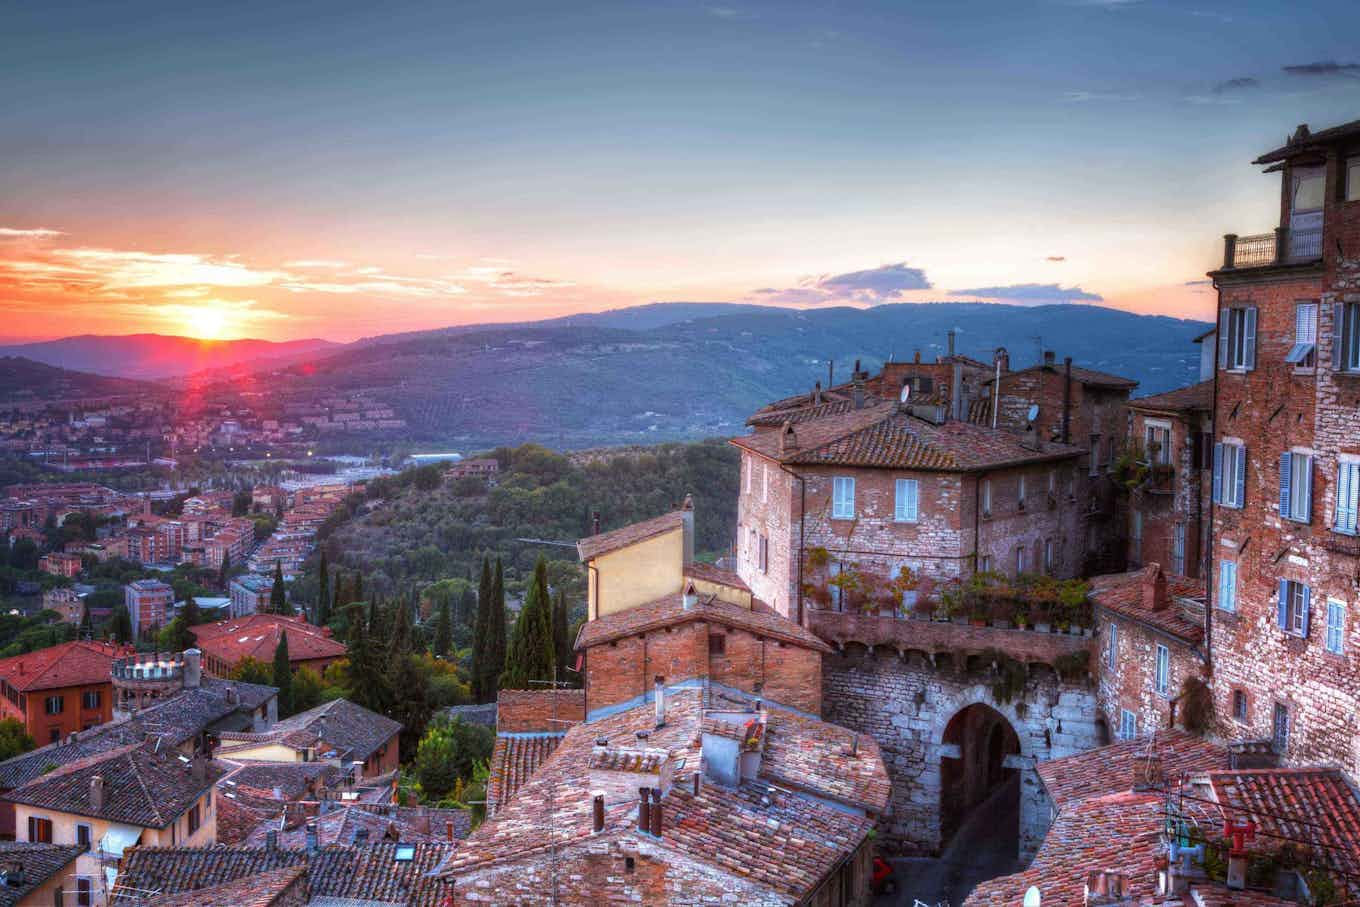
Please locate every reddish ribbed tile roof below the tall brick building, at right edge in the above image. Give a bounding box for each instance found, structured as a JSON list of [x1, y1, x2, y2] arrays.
[[1208, 768, 1360, 884]]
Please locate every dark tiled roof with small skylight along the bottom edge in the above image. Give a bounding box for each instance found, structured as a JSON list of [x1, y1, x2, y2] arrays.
[[112, 842, 454, 907]]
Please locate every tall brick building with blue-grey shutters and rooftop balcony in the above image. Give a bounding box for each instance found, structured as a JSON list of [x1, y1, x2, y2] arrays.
[[1209, 121, 1360, 774]]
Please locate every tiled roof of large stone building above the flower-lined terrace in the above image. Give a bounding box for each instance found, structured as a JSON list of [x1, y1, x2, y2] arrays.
[[732, 403, 1084, 472]]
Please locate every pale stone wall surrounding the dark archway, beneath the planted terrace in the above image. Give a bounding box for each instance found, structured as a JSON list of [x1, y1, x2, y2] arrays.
[[823, 646, 1106, 859]]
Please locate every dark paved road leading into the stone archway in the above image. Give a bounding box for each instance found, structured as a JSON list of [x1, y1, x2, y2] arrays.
[[874, 778, 1020, 907]]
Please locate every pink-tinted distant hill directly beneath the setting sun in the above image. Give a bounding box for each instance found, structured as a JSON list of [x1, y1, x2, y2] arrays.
[[0, 333, 340, 378]]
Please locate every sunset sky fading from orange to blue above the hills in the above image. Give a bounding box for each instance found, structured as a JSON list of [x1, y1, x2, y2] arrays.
[[0, 0, 1360, 341]]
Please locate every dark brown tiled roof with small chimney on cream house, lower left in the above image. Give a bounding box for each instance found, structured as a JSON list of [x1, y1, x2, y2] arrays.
[[5, 745, 226, 828]]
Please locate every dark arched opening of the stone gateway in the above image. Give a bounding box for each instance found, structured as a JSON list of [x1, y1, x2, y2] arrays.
[[940, 702, 1021, 849]]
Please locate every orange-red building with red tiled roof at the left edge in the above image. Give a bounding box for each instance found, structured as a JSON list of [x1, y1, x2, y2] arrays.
[[0, 640, 128, 744]]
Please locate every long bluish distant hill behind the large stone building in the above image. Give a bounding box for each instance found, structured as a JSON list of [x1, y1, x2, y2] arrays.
[[223, 303, 1209, 449]]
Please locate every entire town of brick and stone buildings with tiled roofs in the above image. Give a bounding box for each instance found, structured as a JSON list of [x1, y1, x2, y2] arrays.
[[0, 115, 1360, 907]]
